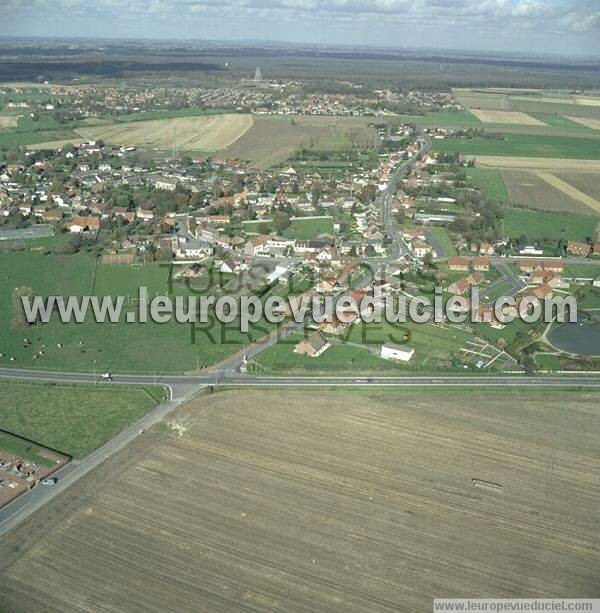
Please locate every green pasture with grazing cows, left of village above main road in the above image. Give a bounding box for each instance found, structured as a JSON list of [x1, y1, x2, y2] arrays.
[[0, 251, 276, 375]]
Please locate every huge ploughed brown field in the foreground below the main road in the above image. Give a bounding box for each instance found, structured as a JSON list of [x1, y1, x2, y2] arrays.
[[0, 390, 600, 613]]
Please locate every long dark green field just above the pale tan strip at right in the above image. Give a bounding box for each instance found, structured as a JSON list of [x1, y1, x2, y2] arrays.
[[433, 134, 600, 160]]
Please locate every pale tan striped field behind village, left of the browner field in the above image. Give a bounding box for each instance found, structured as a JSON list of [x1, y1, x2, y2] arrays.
[[77, 114, 253, 151]]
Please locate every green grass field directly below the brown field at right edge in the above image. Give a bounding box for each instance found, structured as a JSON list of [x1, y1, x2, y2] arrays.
[[503, 209, 598, 241]]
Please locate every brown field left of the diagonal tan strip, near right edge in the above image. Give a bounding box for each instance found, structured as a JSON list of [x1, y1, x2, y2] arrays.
[[503, 170, 595, 213]]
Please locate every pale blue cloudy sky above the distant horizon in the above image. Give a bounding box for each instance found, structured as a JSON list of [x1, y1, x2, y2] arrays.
[[0, 0, 600, 59]]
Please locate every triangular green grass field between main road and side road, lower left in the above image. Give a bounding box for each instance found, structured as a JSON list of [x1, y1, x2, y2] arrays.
[[0, 381, 163, 458]]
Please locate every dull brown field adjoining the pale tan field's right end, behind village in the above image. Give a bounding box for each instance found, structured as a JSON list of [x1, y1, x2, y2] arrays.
[[221, 115, 377, 168]]
